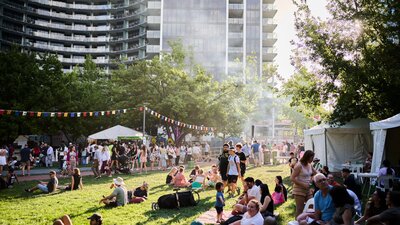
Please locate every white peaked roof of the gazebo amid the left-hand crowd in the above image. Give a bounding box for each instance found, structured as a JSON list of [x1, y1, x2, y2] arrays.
[[88, 125, 143, 140]]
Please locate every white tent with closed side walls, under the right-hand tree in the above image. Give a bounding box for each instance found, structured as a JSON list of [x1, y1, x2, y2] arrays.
[[304, 119, 372, 171]]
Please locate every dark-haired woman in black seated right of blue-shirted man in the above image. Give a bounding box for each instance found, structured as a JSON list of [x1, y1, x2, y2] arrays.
[[329, 186, 356, 225]]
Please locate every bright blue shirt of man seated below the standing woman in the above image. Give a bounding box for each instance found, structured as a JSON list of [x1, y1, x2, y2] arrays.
[[314, 186, 336, 222]]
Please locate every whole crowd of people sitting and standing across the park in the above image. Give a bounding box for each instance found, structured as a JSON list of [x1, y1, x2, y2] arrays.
[[0, 141, 400, 225]]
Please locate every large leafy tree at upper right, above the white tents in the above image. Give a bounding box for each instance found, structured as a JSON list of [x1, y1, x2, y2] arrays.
[[285, 0, 400, 123]]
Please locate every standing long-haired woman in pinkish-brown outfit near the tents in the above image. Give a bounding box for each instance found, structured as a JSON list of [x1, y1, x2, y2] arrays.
[[290, 150, 316, 217]]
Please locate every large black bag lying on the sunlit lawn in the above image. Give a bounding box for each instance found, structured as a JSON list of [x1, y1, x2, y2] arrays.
[[152, 191, 200, 209]]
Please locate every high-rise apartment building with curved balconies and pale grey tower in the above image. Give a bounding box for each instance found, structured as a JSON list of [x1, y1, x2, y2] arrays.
[[0, 0, 277, 79]]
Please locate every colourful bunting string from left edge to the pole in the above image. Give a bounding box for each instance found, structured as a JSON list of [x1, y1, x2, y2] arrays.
[[0, 108, 135, 118]]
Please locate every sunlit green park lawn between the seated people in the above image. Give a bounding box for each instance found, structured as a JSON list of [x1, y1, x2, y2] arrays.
[[0, 165, 295, 225]]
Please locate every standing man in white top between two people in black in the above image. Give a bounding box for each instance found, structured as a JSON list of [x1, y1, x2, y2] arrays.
[[227, 146, 241, 197]]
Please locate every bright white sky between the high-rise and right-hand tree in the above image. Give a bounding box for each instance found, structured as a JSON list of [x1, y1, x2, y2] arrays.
[[275, 0, 328, 79]]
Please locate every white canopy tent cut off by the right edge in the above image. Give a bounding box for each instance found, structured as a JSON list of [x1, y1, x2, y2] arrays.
[[370, 114, 400, 173]]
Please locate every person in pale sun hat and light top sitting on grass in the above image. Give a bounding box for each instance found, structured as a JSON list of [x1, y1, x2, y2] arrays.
[[99, 177, 128, 207]]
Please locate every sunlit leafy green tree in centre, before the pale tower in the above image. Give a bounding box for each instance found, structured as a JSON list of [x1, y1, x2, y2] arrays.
[[112, 42, 252, 144]]
